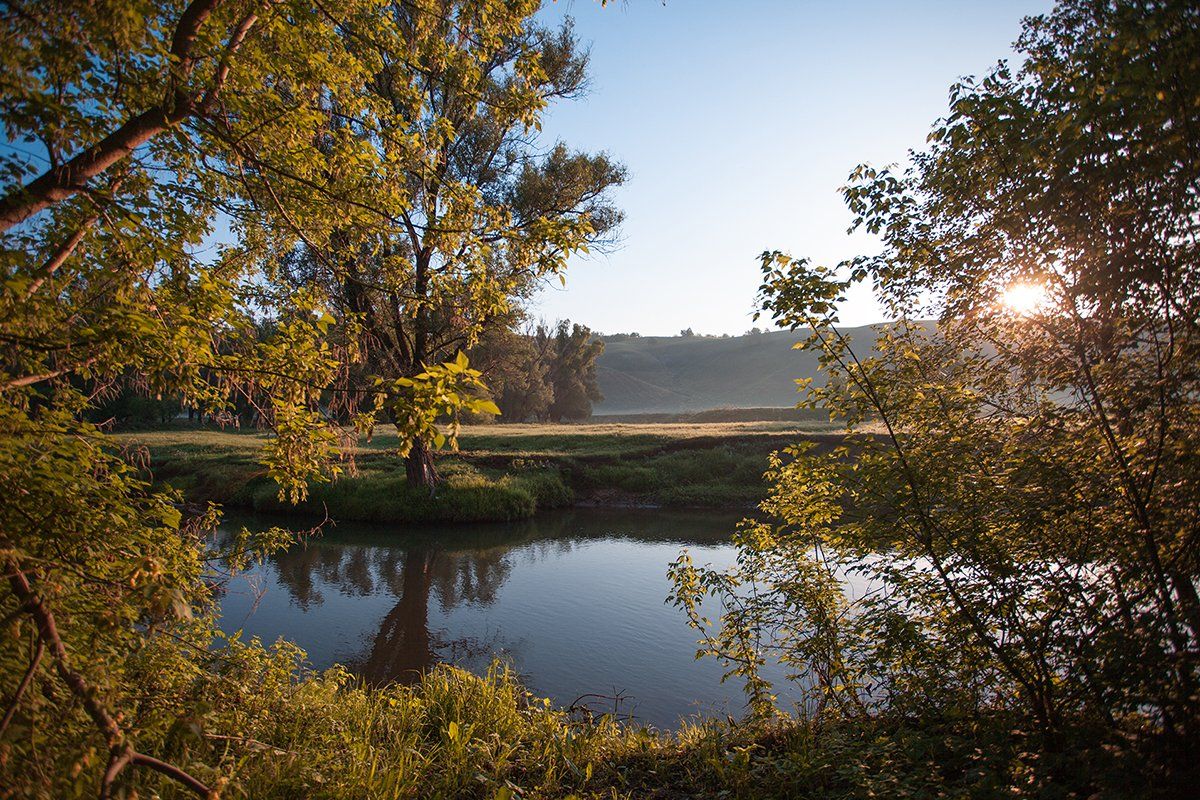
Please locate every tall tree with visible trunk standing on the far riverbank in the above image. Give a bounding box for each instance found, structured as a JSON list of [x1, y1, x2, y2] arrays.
[[283, 9, 625, 487]]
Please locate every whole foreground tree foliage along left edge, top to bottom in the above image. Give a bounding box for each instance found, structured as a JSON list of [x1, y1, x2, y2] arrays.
[[0, 0, 549, 798]]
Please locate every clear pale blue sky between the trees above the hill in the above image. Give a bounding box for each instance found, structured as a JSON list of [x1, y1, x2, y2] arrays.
[[530, 0, 1051, 336]]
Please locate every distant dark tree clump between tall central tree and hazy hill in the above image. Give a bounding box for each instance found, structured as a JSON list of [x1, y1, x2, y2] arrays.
[[470, 320, 604, 422]]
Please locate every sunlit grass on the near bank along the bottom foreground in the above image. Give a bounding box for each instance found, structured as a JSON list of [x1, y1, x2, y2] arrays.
[[114, 642, 1104, 800]]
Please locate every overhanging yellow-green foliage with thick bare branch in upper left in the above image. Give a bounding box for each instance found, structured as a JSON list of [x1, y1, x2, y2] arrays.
[[2, 0, 400, 462]]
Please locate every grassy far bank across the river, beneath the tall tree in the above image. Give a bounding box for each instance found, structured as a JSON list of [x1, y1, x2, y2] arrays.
[[115, 422, 839, 523]]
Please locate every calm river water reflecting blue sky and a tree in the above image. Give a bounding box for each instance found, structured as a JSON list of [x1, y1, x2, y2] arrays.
[[221, 509, 796, 728]]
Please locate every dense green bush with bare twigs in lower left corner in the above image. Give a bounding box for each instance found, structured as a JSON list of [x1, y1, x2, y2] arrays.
[[0, 397, 287, 796]]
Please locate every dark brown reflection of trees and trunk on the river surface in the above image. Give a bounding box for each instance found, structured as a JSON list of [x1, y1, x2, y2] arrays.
[[219, 510, 733, 684]]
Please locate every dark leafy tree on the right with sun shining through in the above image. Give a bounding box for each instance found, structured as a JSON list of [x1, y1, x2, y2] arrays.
[[674, 0, 1200, 795]]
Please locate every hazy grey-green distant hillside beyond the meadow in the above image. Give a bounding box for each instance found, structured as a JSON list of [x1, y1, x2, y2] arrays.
[[594, 327, 875, 414]]
